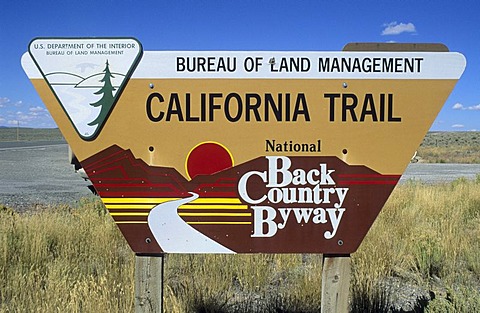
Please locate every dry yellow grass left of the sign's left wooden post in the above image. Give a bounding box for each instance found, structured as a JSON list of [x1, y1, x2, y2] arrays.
[[0, 203, 134, 312]]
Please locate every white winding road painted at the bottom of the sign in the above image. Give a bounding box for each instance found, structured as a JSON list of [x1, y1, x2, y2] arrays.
[[148, 192, 235, 253]]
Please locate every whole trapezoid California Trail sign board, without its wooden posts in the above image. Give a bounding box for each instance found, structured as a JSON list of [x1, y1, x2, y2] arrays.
[[22, 38, 466, 254]]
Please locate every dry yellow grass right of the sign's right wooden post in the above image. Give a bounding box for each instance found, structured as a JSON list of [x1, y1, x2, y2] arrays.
[[352, 177, 480, 312]]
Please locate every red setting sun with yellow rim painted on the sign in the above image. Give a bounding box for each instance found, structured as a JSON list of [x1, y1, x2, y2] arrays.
[[185, 141, 233, 179]]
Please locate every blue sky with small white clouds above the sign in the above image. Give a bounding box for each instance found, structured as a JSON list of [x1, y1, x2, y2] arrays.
[[0, 0, 480, 131]]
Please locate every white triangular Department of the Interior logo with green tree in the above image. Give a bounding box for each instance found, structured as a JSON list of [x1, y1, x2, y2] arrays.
[[29, 38, 142, 140]]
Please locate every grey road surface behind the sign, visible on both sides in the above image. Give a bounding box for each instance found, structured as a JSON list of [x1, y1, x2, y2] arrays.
[[0, 141, 480, 210]]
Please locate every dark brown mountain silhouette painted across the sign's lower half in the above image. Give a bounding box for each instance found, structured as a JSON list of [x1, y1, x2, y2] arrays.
[[81, 145, 400, 253]]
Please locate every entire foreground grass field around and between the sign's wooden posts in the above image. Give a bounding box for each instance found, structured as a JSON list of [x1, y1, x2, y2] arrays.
[[0, 177, 480, 313]]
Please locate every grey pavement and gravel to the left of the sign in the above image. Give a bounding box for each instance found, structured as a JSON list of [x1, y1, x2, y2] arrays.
[[0, 142, 91, 210]]
